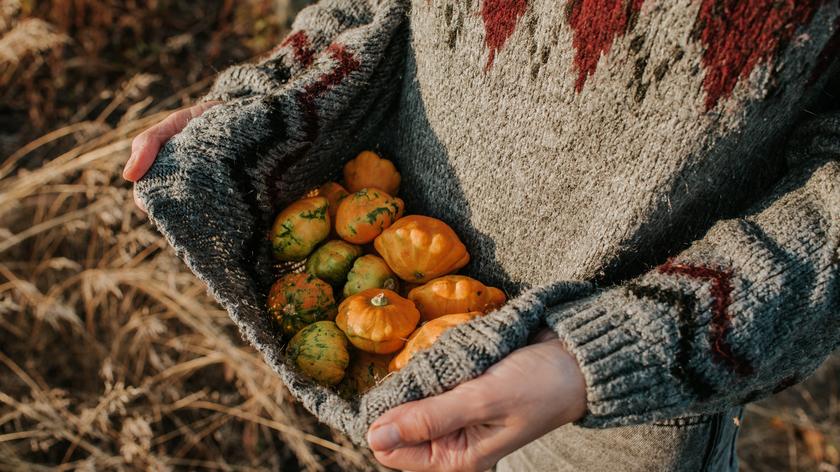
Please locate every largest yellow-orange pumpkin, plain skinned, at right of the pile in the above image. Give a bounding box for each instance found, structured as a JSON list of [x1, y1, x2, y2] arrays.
[[373, 215, 470, 283]]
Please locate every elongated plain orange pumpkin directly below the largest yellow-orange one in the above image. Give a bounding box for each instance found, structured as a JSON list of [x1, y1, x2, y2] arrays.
[[408, 275, 507, 321]]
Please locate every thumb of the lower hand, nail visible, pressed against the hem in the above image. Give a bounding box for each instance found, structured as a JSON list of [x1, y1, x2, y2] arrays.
[[367, 388, 484, 451]]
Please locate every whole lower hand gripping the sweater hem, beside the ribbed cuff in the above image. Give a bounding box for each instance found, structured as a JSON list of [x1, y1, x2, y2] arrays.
[[368, 333, 586, 471]]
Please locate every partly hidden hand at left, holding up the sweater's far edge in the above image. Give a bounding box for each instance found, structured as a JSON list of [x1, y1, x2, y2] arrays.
[[123, 102, 220, 212]]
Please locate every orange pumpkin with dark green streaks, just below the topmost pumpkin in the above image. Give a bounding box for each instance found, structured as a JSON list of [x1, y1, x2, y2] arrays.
[[335, 188, 405, 244]]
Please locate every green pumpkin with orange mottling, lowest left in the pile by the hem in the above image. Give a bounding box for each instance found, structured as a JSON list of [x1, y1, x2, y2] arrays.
[[286, 321, 350, 385]]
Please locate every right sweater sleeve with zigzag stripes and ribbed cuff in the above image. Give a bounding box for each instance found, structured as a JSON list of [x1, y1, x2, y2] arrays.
[[547, 113, 840, 427]]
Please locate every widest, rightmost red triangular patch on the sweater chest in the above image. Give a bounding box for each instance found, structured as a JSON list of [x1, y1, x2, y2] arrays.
[[695, 0, 826, 111]]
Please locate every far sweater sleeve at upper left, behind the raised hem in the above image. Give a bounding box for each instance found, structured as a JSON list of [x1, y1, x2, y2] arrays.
[[203, 0, 404, 101]]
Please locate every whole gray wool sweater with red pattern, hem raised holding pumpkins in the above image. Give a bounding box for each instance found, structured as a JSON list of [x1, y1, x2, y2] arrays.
[[138, 0, 840, 452]]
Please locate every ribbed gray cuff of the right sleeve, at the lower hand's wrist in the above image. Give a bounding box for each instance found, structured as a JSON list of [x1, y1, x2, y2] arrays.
[[546, 287, 688, 428]]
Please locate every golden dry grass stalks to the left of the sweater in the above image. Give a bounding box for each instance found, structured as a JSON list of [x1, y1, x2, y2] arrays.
[[0, 0, 378, 470]]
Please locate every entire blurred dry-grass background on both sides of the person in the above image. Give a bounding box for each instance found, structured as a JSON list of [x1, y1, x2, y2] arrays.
[[0, 0, 840, 472]]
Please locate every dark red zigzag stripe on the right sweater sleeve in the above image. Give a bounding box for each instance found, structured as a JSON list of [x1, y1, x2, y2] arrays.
[[658, 261, 754, 375]]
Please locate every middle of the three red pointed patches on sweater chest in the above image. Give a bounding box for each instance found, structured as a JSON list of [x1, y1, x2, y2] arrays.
[[568, 0, 644, 92]]
